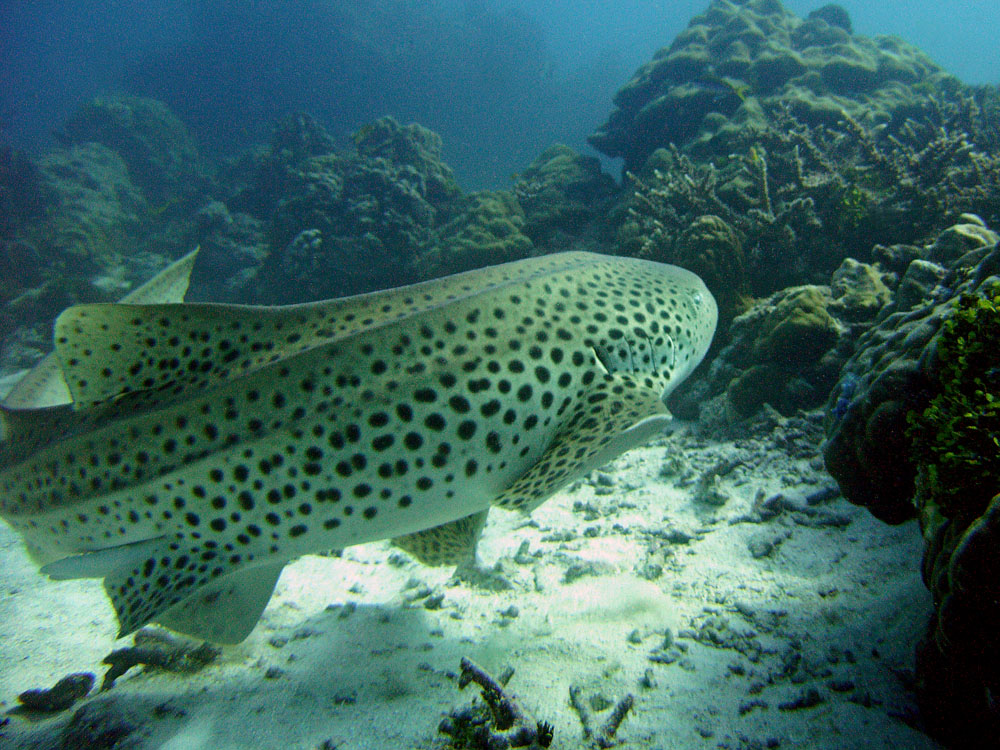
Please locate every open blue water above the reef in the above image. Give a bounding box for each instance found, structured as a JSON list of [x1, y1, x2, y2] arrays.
[[0, 0, 1000, 189]]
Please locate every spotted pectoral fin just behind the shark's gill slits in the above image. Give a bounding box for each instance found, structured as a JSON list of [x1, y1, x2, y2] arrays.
[[493, 373, 671, 513]]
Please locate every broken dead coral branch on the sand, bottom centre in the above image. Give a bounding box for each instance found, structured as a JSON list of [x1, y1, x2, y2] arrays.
[[438, 658, 553, 750]]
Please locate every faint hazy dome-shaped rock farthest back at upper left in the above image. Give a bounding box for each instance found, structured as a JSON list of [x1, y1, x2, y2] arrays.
[[55, 96, 202, 203]]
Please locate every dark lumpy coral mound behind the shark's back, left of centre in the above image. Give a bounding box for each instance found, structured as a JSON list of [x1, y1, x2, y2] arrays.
[[251, 117, 461, 303]]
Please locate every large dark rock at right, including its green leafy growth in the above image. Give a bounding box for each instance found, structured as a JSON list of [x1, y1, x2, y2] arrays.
[[824, 224, 1000, 746]]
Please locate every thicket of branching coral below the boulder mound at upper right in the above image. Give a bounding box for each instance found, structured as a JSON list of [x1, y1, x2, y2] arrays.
[[619, 100, 1000, 295]]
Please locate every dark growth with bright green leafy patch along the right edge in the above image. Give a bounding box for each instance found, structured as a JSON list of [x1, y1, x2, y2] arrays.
[[907, 286, 1000, 738]]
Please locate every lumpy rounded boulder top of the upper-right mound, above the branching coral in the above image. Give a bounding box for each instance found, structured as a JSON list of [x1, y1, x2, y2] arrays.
[[589, 0, 958, 170]]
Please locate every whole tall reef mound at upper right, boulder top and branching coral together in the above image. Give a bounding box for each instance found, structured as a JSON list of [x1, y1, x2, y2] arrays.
[[592, 0, 1000, 296]]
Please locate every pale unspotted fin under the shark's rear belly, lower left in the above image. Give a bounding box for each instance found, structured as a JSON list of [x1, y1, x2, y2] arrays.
[[155, 562, 285, 644]]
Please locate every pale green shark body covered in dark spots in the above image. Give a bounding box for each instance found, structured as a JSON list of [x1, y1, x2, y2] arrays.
[[0, 253, 716, 634]]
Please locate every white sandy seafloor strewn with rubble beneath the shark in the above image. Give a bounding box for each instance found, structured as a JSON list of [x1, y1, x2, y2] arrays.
[[0, 419, 938, 750]]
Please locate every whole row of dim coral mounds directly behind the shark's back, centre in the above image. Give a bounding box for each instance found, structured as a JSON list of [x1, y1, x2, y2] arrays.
[[245, 115, 614, 302]]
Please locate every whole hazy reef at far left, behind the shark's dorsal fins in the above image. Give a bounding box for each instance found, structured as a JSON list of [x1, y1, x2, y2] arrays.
[[0, 97, 220, 367]]
